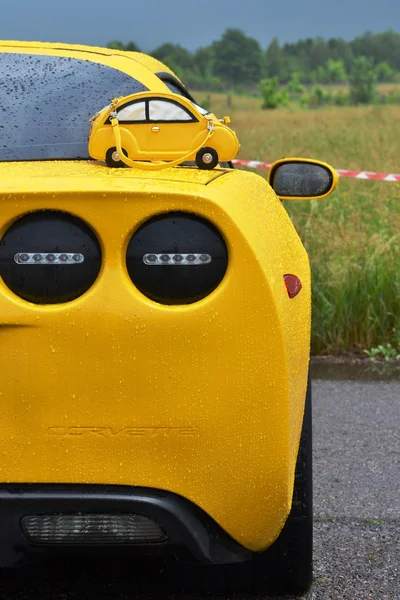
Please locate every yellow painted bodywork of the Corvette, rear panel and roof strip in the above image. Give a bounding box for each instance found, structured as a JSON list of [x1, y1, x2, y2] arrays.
[[0, 44, 338, 551]]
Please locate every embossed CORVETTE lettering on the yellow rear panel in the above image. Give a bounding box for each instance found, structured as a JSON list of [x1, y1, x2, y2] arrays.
[[47, 426, 197, 438]]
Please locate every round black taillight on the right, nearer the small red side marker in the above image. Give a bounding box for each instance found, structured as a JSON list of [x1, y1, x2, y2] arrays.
[[126, 212, 228, 305]]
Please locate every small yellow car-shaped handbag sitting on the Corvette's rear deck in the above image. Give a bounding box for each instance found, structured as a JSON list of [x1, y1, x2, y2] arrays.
[[89, 92, 239, 169]]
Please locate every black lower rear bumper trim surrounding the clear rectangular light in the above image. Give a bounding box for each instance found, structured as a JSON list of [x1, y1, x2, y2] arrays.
[[0, 484, 251, 568]]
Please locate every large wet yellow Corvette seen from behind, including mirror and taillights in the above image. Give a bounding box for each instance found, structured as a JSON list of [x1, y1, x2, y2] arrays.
[[0, 42, 337, 592]]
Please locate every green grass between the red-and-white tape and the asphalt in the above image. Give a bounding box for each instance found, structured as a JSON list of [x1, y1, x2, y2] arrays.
[[286, 190, 400, 354]]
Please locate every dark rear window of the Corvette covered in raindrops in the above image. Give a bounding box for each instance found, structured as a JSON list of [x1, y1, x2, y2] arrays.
[[0, 52, 148, 161]]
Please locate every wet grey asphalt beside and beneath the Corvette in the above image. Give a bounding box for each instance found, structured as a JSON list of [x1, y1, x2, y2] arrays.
[[0, 380, 400, 600]]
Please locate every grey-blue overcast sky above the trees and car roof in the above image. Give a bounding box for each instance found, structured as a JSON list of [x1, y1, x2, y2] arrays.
[[0, 0, 400, 51]]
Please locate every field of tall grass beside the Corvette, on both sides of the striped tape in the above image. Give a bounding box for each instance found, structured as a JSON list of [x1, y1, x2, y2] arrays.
[[198, 95, 400, 353]]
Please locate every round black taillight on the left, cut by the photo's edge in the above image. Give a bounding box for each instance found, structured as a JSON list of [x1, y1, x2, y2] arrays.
[[0, 210, 101, 304]]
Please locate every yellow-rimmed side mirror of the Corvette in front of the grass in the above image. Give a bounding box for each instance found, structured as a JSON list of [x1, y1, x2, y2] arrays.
[[267, 158, 339, 200]]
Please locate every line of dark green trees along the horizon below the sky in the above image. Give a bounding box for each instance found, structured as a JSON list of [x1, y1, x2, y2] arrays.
[[108, 28, 400, 91]]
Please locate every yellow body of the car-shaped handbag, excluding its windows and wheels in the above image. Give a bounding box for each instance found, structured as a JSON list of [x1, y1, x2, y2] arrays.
[[89, 92, 239, 167]]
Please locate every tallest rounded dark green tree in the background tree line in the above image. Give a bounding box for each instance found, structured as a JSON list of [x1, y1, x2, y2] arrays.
[[212, 29, 262, 85]]
